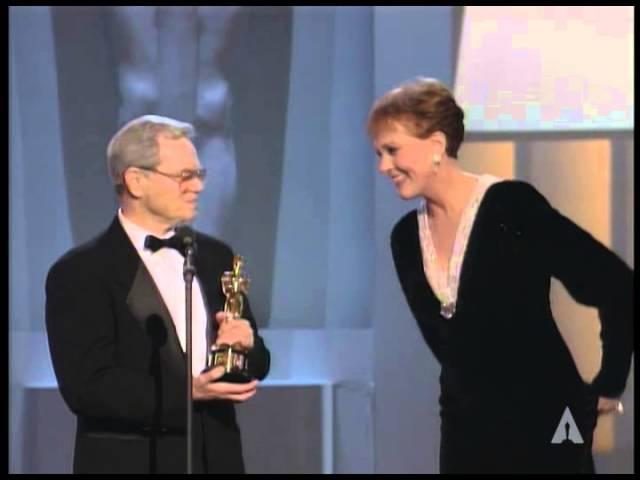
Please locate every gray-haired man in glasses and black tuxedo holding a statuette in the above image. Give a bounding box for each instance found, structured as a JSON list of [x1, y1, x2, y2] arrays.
[[46, 115, 270, 473]]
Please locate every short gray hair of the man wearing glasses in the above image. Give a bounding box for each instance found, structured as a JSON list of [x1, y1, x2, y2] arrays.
[[107, 115, 195, 194]]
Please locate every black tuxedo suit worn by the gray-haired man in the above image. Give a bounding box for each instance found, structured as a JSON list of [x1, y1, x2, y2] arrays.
[[46, 217, 270, 473]]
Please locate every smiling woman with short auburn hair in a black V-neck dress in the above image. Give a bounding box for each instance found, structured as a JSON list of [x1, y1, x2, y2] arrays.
[[368, 79, 633, 473]]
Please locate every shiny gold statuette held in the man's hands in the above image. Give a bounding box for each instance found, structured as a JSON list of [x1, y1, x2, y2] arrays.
[[208, 255, 252, 383]]
